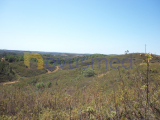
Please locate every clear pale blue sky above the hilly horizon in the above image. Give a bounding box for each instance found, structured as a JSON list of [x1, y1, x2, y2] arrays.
[[0, 0, 160, 55]]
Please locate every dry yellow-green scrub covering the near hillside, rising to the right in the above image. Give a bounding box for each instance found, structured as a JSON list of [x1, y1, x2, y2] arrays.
[[0, 54, 160, 120]]
